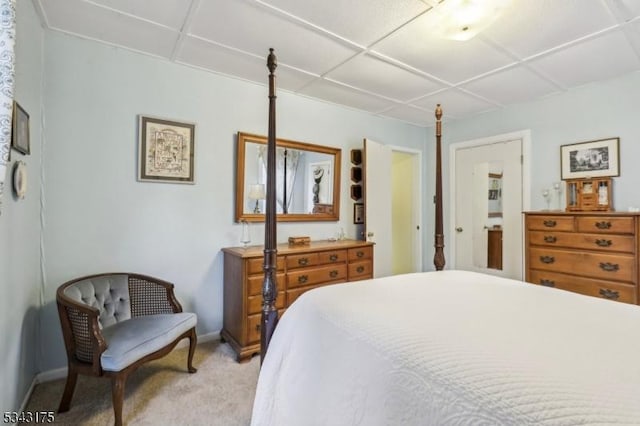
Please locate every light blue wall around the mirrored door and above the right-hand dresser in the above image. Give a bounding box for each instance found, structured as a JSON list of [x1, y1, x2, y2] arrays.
[[427, 72, 640, 268]]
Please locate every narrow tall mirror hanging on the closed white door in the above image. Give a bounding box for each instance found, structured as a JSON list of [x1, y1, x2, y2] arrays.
[[473, 161, 503, 270]]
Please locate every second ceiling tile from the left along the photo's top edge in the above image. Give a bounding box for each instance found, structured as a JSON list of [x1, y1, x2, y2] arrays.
[[85, 0, 191, 30]]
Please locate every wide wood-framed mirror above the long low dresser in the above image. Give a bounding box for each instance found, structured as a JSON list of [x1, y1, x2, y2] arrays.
[[235, 132, 342, 222]]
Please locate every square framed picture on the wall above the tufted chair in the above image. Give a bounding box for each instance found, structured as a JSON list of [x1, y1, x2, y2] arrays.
[[138, 115, 196, 184]]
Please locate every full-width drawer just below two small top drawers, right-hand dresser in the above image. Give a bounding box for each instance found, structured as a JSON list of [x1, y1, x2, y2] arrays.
[[529, 231, 635, 253]]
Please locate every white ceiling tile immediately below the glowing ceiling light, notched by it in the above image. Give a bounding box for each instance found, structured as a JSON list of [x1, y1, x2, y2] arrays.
[[372, 12, 513, 83]]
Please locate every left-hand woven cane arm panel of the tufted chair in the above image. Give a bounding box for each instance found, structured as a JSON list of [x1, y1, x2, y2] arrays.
[[56, 288, 107, 375]]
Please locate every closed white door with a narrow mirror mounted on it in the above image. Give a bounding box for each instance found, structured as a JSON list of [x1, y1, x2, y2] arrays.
[[454, 139, 523, 279]]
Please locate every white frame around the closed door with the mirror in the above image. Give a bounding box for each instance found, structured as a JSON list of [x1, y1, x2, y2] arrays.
[[449, 129, 531, 280]]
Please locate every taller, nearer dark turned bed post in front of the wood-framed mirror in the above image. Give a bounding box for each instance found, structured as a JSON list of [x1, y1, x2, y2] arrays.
[[260, 49, 278, 365]]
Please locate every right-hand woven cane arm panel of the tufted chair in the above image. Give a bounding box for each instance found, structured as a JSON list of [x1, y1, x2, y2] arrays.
[[128, 273, 182, 317]]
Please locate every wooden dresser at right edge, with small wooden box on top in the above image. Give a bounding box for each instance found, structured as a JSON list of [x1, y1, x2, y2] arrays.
[[525, 212, 640, 304]]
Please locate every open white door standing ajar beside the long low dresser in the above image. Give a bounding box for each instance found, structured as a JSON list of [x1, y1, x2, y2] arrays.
[[364, 139, 392, 278]]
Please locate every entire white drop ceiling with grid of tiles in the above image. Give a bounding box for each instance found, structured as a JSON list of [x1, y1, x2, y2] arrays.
[[33, 0, 640, 126]]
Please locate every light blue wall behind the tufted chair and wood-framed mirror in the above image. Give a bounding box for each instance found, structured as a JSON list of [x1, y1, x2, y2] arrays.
[[41, 32, 425, 370]]
